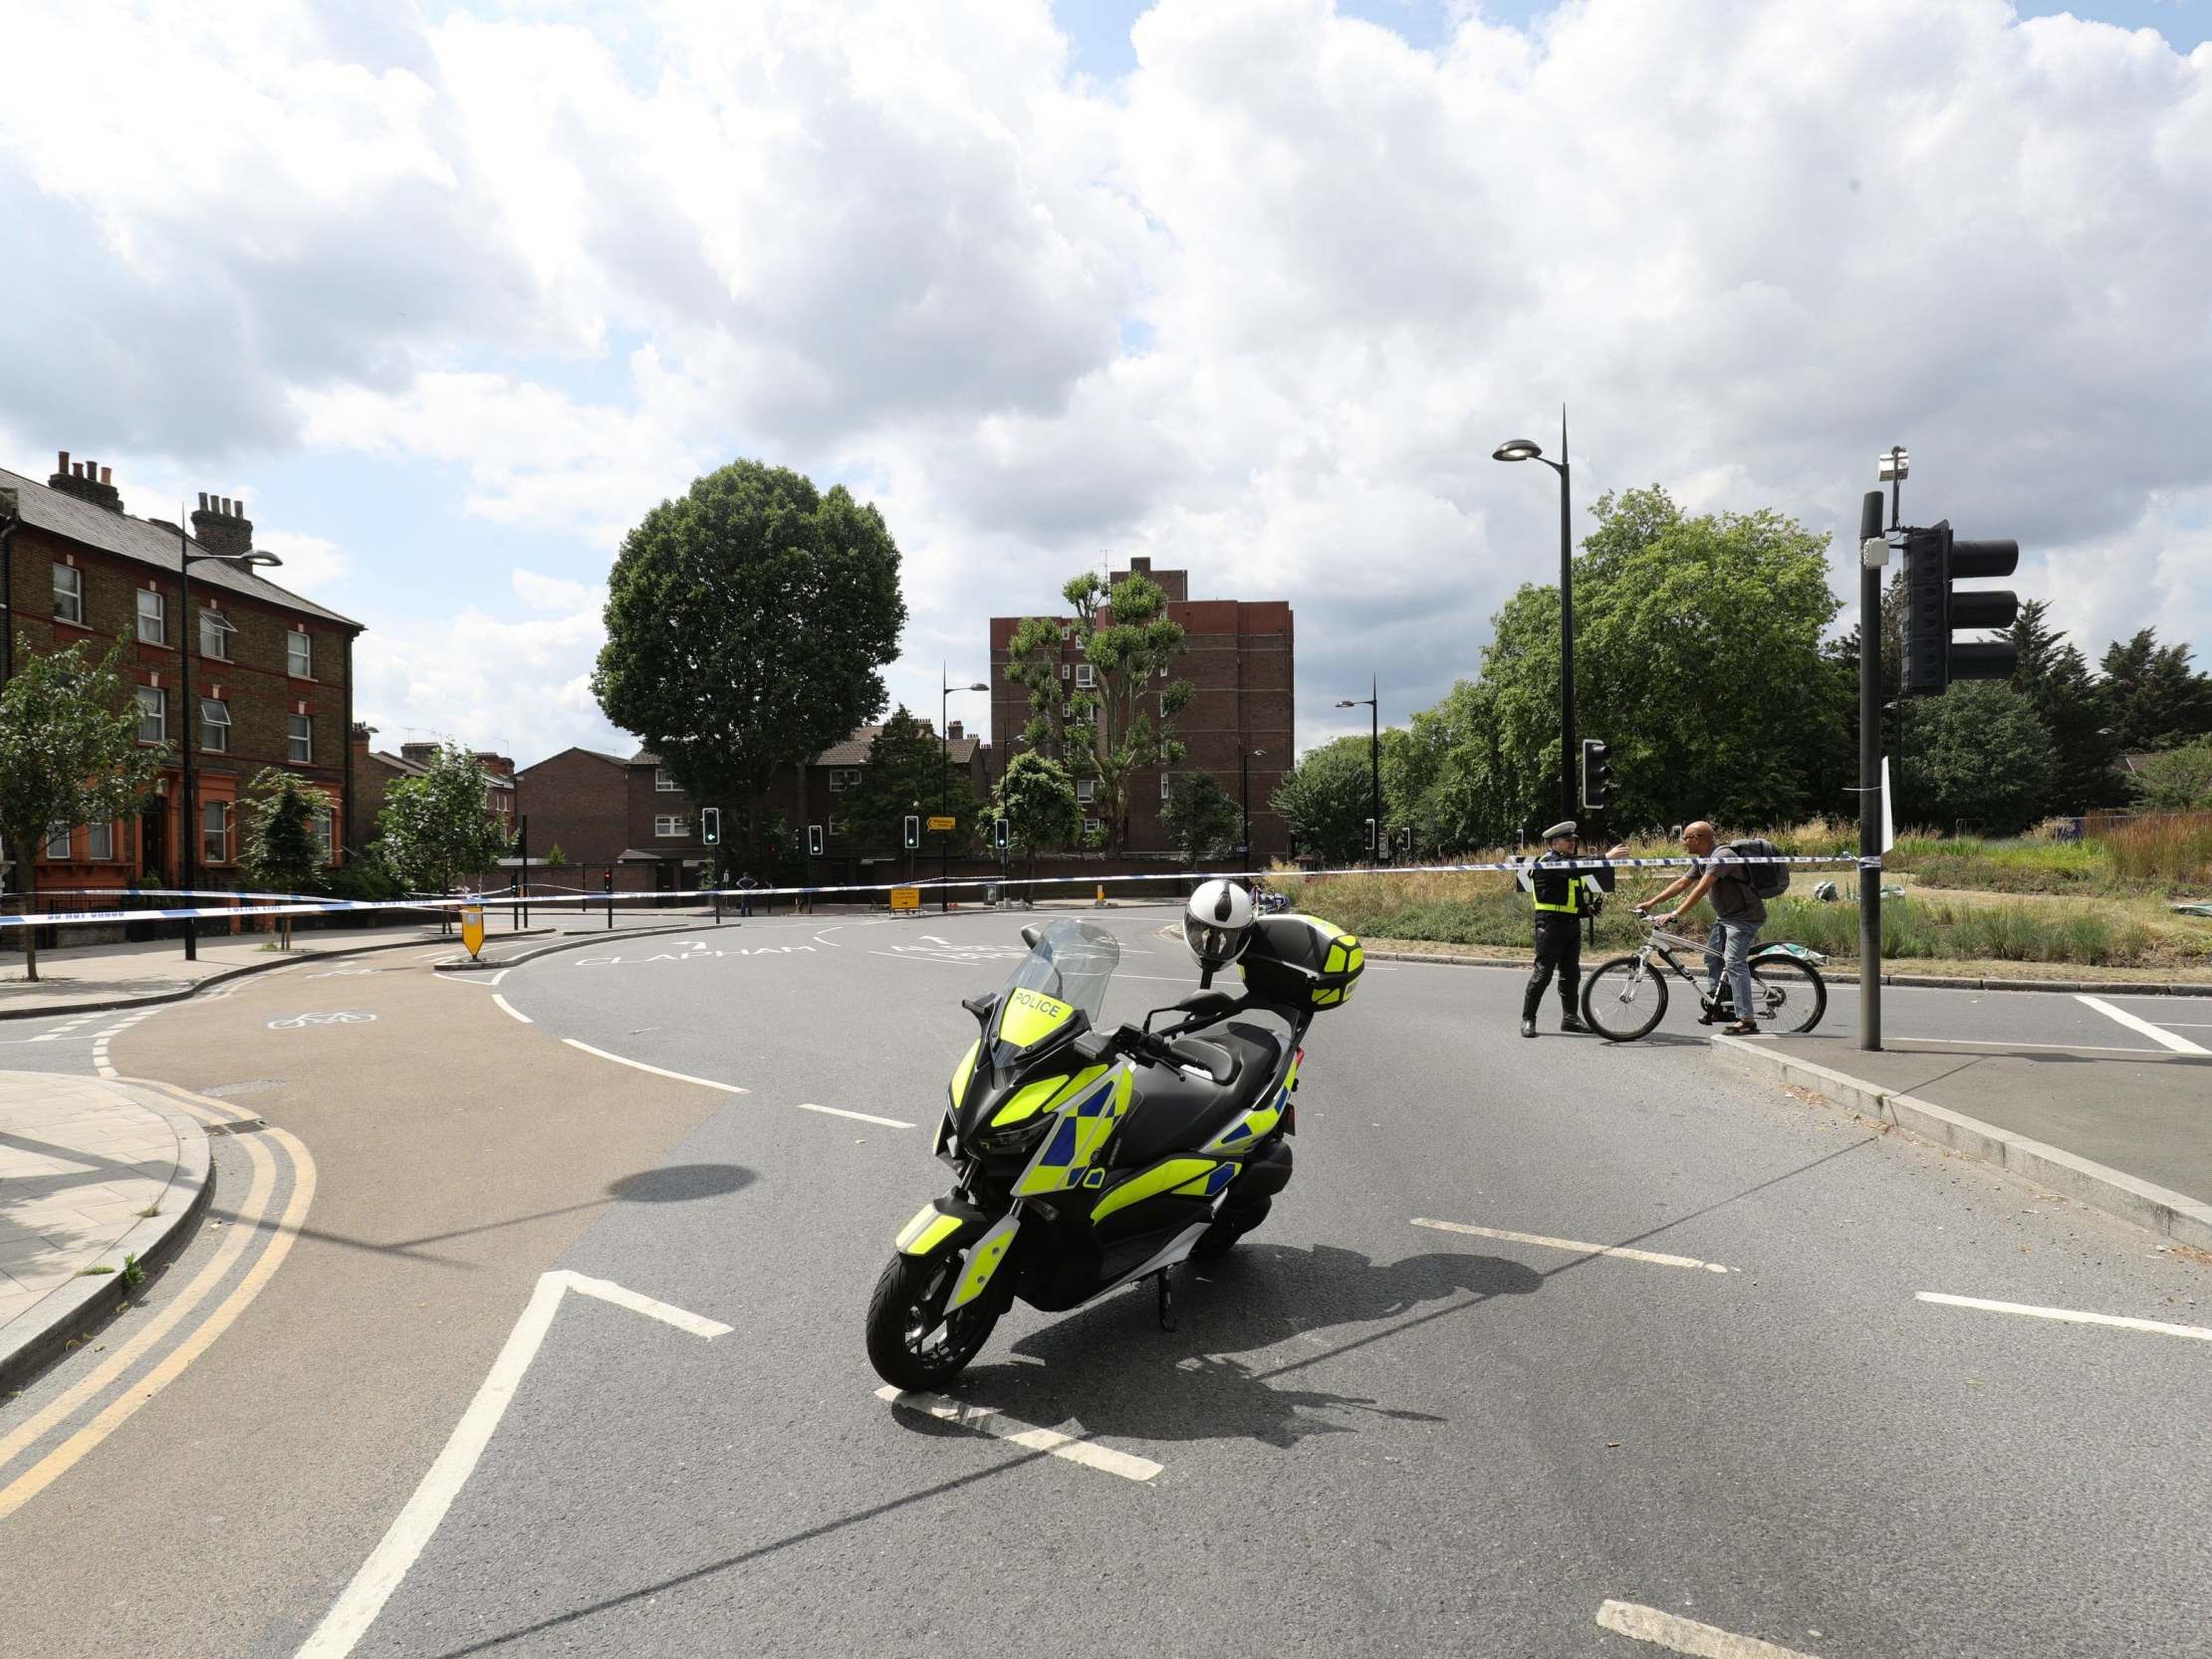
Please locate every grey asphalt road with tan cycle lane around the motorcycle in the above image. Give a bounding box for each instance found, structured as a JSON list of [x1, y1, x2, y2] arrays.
[[0, 911, 2212, 1659]]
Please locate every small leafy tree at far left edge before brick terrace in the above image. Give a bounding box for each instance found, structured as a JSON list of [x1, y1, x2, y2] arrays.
[[0, 632, 167, 980]]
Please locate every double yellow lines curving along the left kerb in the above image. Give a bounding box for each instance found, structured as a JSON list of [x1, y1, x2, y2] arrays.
[[0, 1079, 317, 1520]]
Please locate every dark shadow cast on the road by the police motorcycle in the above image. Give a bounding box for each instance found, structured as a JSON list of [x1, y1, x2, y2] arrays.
[[946, 1241, 1544, 1447]]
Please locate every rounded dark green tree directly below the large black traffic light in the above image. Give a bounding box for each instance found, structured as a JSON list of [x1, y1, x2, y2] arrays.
[[1904, 679, 2058, 833]]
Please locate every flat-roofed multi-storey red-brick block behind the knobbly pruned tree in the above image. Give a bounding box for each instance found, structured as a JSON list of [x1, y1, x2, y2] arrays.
[[991, 558, 1297, 858]]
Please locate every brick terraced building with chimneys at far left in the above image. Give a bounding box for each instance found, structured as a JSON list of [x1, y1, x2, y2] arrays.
[[0, 451, 361, 887]]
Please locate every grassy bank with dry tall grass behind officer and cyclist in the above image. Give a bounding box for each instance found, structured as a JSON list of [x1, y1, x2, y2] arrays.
[[1272, 862, 2212, 978]]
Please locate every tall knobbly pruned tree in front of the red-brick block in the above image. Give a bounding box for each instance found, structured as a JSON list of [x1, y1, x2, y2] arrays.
[[1007, 571, 1192, 851]]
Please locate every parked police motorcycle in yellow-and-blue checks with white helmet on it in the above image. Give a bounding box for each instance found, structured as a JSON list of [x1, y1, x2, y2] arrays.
[[867, 880, 1364, 1389]]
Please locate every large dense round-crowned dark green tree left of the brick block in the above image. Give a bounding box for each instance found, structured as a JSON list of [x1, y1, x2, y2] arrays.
[[591, 460, 907, 871]]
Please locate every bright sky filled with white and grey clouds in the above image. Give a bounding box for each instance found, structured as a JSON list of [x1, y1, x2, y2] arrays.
[[0, 0, 2212, 763]]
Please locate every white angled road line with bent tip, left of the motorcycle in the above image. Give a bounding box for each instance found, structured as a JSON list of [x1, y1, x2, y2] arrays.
[[294, 1268, 730, 1659]]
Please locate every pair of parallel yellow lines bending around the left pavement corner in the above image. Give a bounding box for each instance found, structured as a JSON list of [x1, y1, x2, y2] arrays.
[[0, 1103, 317, 1518]]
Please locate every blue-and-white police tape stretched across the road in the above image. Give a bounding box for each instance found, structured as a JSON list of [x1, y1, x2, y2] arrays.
[[0, 853, 1880, 927]]
